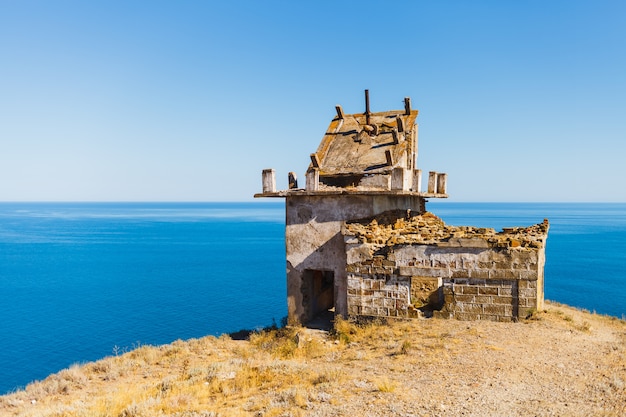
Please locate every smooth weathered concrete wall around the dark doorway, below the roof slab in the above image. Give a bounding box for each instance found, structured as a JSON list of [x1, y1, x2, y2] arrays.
[[285, 195, 424, 323]]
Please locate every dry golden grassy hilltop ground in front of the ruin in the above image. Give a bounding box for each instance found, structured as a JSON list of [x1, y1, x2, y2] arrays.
[[0, 304, 626, 417]]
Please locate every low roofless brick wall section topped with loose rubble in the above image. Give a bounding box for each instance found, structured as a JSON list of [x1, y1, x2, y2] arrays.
[[342, 211, 548, 321]]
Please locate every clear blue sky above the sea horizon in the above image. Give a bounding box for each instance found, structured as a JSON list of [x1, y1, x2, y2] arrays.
[[0, 0, 626, 202]]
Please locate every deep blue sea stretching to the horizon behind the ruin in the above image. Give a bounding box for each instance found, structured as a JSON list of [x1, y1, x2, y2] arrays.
[[0, 201, 626, 394]]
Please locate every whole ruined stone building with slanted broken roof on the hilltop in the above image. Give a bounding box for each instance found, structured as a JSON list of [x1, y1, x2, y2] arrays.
[[255, 90, 548, 323]]
